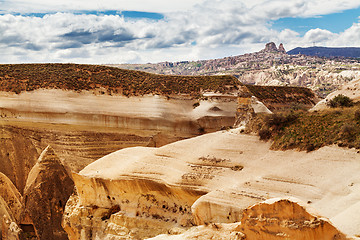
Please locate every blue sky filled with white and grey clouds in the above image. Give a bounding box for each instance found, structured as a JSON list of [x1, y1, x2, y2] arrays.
[[0, 0, 360, 64]]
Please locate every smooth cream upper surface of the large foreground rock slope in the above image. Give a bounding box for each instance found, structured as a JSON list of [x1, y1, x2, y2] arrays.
[[79, 131, 360, 235]]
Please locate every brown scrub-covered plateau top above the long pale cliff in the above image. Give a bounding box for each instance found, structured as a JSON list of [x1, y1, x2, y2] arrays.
[[0, 64, 239, 96]]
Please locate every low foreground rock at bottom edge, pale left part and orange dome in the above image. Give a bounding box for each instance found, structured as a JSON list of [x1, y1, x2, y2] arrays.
[[151, 198, 348, 240]]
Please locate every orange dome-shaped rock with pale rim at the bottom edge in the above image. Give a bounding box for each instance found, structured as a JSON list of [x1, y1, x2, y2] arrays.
[[239, 199, 346, 240]]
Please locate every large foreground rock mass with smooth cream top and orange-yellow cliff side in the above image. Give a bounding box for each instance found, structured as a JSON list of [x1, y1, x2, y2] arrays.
[[63, 131, 360, 239]]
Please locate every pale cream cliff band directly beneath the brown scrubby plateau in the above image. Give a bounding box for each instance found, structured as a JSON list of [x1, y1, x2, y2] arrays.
[[0, 89, 236, 133]]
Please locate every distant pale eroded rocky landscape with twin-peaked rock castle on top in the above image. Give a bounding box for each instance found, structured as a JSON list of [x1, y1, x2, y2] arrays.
[[112, 43, 360, 97]]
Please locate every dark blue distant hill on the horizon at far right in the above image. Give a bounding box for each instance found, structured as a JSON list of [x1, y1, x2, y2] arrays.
[[287, 47, 360, 58]]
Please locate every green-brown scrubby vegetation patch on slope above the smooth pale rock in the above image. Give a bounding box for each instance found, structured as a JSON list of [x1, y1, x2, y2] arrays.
[[248, 104, 360, 151]]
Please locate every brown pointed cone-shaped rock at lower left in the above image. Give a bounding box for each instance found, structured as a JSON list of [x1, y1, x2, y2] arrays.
[[20, 146, 74, 240]]
